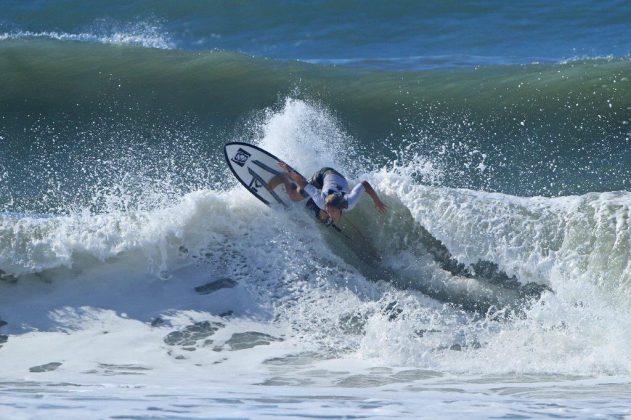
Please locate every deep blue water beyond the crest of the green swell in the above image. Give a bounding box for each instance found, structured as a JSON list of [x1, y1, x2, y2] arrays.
[[0, 0, 631, 69]]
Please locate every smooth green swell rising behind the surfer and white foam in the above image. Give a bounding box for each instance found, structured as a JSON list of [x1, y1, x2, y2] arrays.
[[0, 39, 631, 210]]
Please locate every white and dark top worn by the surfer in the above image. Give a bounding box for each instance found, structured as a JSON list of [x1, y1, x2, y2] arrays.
[[304, 168, 366, 210]]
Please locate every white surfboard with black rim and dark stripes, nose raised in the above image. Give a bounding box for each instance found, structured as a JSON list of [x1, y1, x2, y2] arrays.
[[224, 142, 298, 207]]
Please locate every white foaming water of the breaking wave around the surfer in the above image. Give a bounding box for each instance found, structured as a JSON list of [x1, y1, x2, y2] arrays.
[[0, 99, 631, 418]]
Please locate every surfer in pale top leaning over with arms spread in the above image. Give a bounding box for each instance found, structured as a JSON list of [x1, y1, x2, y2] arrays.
[[268, 161, 387, 223]]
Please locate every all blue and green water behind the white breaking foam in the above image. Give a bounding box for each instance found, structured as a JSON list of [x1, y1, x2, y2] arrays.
[[0, 1, 631, 212]]
